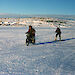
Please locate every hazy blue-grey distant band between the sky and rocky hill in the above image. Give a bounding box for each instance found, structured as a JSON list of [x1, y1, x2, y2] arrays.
[[0, 13, 75, 21]]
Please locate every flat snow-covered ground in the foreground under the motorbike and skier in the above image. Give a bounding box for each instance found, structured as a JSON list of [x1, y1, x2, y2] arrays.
[[0, 20, 75, 75]]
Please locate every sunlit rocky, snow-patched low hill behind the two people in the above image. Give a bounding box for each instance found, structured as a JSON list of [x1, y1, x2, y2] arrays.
[[0, 17, 74, 28]]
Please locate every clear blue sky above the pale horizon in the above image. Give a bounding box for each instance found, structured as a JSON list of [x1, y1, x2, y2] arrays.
[[0, 0, 75, 15]]
